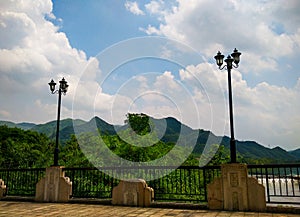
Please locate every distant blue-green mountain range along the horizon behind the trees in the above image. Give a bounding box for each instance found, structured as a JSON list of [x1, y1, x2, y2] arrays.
[[0, 117, 300, 163]]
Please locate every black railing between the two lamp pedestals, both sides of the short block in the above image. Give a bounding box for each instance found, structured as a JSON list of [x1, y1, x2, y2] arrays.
[[64, 166, 220, 202]]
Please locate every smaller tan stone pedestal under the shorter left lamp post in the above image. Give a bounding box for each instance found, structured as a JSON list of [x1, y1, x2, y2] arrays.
[[35, 166, 72, 202]]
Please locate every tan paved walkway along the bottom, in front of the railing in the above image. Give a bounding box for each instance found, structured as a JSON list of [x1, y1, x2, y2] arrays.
[[0, 201, 299, 217]]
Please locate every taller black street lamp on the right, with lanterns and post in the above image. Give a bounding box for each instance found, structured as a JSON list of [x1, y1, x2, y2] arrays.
[[215, 48, 242, 163]]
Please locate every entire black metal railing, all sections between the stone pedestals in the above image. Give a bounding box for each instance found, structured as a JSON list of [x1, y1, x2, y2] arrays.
[[0, 164, 300, 204]]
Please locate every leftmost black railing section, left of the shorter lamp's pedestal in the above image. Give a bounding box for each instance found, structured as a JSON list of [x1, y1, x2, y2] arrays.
[[0, 168, 46, 196]]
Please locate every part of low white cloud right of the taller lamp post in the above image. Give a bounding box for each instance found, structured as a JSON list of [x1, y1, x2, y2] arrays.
[[233, 80, 300, 149]]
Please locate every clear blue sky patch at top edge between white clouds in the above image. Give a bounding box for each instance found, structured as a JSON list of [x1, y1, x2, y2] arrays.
[[53, 0, 157, 56]]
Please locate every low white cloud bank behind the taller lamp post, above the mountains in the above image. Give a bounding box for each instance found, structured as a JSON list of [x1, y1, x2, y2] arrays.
[[179, 60, 300, 149]]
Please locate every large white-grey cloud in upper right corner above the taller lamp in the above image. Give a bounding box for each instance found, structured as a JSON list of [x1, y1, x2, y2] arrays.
[[144, 0, 300, 72]]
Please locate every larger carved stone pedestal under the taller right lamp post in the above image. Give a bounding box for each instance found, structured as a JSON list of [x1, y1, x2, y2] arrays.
[[208, 163, 266, 211]]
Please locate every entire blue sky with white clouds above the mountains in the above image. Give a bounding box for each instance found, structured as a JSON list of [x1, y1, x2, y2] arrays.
[[0, 0, 300, 150]]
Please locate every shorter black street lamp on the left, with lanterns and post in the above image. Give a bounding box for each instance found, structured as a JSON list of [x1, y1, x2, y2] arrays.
[[48, 78, 69, 166]]
